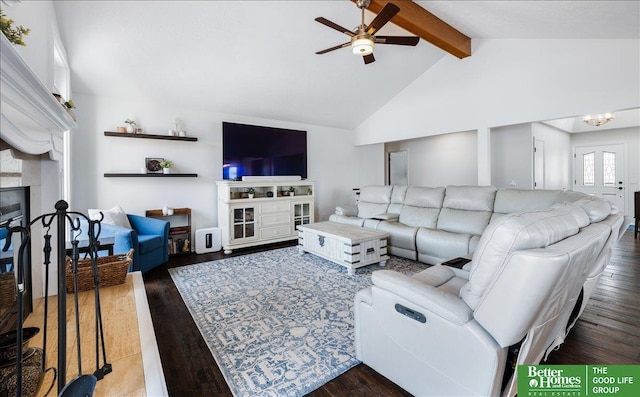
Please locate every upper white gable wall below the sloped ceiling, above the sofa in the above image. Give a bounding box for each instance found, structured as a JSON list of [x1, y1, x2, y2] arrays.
[[356, 39, 640, 144]]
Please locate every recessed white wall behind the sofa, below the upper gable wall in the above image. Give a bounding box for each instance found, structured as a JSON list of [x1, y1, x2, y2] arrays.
[[385, 131, 478, 187]]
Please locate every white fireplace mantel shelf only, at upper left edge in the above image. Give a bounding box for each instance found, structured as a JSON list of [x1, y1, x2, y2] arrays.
[[0, 34, 77, 160]]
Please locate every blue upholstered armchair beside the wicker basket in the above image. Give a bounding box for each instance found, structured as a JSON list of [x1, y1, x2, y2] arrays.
[[82, 214, 169, 273]]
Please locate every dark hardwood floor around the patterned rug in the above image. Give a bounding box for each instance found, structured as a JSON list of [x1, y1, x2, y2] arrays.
[[144, 231, 640, 397]]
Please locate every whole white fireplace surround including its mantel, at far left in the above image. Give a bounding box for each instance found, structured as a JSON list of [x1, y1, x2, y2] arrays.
[[0, 34, 77, 298]]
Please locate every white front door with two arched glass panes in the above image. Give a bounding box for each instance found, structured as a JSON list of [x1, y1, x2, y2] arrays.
[[574, 144, 625, 213]]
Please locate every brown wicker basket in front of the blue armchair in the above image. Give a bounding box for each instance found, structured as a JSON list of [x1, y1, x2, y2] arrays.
[[67, 249, 133, 294]]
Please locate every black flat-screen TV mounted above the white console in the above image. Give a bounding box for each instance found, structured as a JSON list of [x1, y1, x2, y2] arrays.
[[222, 122, 307, 180]]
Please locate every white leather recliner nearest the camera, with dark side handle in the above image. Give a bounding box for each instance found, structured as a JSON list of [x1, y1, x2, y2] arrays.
[[355, 200, 622, 396]]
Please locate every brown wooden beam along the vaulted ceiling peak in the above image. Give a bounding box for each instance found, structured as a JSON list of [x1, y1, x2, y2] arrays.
[[351, 0, 471, 59]]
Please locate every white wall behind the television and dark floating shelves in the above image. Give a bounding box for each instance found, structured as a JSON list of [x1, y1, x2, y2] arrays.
[[71, 95, 364, 229]]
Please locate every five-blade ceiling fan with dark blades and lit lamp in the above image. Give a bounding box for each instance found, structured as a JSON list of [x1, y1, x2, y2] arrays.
[[315, 0, 420, 64]]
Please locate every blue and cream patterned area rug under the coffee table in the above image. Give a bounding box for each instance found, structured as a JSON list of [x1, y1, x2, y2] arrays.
[[169, 247, 427, 396]]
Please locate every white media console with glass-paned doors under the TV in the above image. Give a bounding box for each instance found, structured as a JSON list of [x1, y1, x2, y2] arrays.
[[216, 177, 315, 254]]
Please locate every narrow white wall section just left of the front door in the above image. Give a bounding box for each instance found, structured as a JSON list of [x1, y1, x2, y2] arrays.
[[531, 123, 573, 190]]
